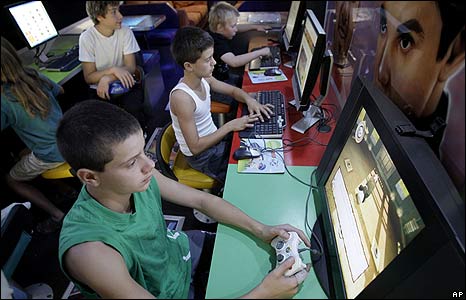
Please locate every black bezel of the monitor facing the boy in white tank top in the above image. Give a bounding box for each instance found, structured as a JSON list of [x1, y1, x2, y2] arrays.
[[292, 9, 326, 111]]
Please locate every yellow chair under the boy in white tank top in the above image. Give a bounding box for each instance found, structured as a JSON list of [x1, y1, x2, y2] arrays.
[[156, 123, 219, 223]]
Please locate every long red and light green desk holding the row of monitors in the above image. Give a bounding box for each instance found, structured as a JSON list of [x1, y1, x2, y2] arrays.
[[206, 36, 338, 299]]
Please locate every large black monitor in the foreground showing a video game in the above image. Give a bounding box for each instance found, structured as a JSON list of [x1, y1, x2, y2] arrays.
[[311, 78, 465, 299]]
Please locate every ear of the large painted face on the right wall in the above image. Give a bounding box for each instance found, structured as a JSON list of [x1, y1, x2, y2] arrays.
[[439, 27, 465, 82]]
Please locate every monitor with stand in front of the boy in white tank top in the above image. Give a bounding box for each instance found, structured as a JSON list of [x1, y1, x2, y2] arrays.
[[291, 9, 333, 133]]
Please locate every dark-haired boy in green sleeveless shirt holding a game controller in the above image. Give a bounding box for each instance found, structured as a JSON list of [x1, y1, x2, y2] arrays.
[[57, 100, 310, 299]]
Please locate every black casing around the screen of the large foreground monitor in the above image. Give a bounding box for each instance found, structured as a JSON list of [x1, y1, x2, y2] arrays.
[[314, 77, 465, 298]]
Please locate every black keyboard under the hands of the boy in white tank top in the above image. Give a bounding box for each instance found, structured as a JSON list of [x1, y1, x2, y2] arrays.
[[239, 91, 286, 138]]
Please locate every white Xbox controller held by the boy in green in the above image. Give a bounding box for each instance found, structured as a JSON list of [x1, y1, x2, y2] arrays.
[[270, 231, 306, 276]]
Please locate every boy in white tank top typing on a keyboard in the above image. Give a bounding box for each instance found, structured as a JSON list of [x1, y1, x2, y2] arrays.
[[170, 27, 273, 184]]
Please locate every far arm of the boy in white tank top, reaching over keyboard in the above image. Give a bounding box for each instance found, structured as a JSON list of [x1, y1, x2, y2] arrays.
[[206, 77, 273, 122]]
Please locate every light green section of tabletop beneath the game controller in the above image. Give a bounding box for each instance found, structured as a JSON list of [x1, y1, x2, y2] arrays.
[[206, 164, 327, 299]]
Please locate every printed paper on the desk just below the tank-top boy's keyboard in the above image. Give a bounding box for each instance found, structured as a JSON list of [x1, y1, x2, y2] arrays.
[[238, 139, 285, 174]]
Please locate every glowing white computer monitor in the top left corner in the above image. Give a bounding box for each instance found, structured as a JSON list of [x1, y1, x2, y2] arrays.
[[8, 1, 58, 59]]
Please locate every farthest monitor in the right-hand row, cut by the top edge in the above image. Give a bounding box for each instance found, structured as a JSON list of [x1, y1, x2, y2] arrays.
[[283, 1, 306, 51]]
